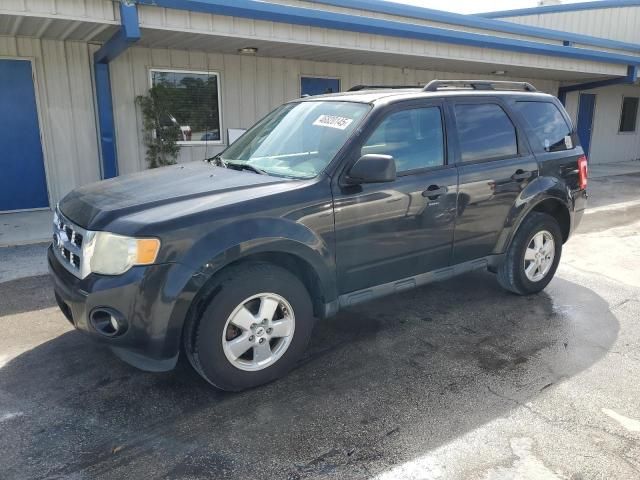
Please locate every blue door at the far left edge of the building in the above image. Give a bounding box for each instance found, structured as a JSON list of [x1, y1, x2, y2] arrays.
[[0, 60, 49, 211]]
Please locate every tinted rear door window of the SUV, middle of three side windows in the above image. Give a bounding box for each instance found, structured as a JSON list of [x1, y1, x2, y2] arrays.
[[455, 103, 518, 162]]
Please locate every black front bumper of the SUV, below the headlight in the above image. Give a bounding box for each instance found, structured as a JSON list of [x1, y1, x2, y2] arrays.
[[47, 247, 192, 371]]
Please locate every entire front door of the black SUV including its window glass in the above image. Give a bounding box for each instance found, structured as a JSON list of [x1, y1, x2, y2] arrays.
[[334, 102, 458, 294]]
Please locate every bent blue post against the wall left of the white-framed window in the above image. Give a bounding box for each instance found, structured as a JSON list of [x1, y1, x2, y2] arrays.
[[93, 2, 140, 178]]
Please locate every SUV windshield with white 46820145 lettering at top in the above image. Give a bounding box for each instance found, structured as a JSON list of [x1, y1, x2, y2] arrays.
[[220, 101, 370, 178]]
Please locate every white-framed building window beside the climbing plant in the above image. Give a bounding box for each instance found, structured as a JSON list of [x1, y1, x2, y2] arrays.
[[150, 69, 222, 144]]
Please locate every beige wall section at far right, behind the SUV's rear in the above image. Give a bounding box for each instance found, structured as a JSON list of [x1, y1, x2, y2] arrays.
[[567, 85, 640, 163]]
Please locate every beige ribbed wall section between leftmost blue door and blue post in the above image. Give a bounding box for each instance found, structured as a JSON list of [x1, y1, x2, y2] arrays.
[[0, 36, 100, 205]]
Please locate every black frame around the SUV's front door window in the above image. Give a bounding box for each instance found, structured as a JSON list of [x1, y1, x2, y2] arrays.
[[356, 100, 454, 178]]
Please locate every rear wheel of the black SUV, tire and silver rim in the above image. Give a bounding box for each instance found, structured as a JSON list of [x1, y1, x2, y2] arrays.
[[497, 212, 562, 295]]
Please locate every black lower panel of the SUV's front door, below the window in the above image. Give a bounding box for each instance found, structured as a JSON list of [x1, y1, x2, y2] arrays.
[[334, 168, 458, 294]]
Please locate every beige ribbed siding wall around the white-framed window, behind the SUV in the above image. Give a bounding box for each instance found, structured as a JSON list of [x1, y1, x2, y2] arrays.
[[111, 47, 558, 174]]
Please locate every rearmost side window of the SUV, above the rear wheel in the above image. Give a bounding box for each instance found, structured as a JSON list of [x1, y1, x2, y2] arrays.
[[516, 102, 573, 152]]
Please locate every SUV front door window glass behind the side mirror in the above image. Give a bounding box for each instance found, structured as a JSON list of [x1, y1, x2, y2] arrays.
[[361, 107, 444, 173]]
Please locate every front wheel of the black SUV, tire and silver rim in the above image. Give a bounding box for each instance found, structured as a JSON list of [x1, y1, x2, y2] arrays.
[[184, 263, 315, 392]]
